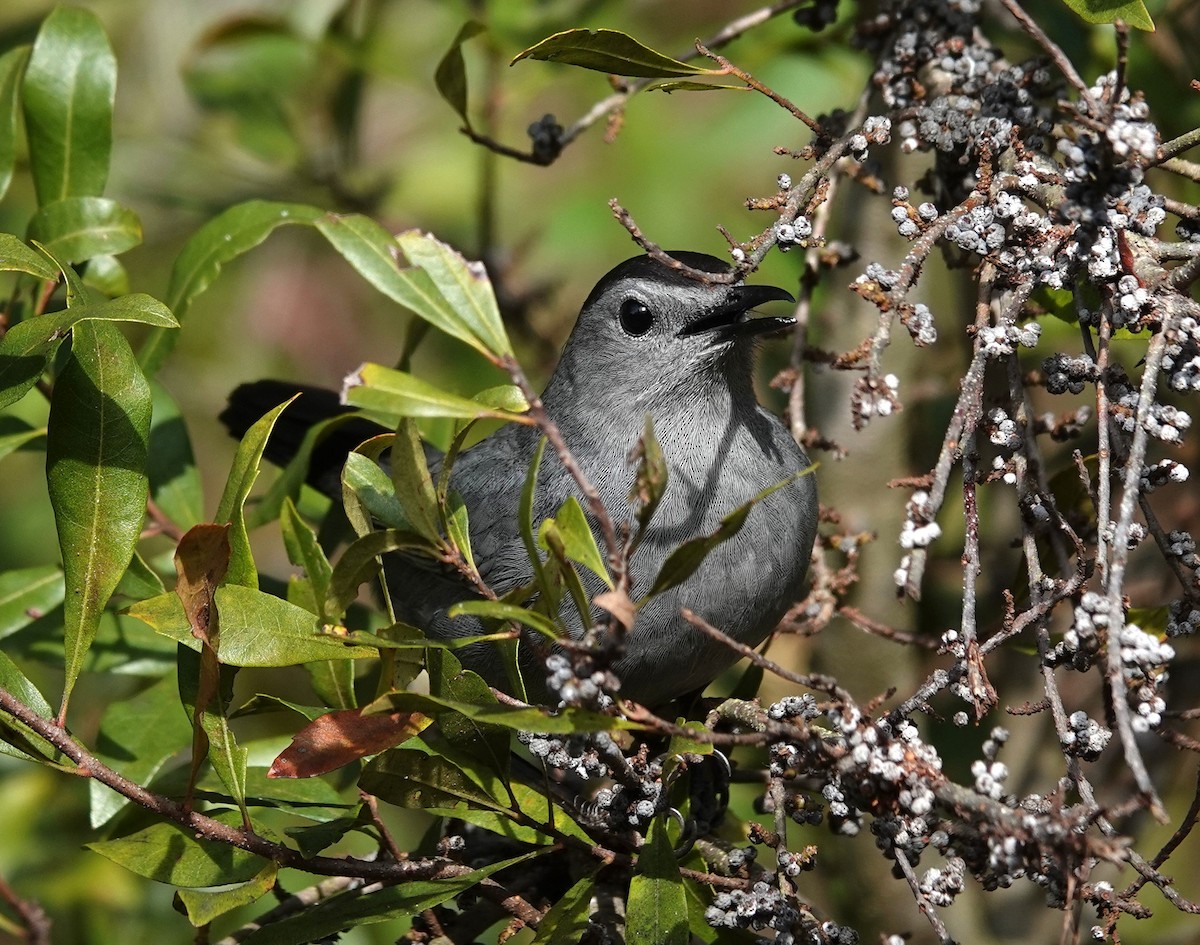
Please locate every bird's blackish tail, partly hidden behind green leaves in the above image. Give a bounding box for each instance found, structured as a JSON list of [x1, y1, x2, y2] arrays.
[[218, 380, 388, 498]]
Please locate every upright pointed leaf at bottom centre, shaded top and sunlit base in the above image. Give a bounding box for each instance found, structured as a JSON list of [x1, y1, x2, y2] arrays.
[[625, 814, 690, 945]]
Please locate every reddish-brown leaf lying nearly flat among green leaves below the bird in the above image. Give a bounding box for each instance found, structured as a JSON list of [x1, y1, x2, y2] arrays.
[[266, 709, 432, 777]]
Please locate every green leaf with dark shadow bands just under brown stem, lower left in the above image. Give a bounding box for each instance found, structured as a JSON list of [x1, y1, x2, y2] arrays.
[[86, 811, 268, 887]]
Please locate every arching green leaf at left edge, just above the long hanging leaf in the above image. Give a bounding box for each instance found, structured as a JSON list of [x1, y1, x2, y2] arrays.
[[0, 294, 178, 407]]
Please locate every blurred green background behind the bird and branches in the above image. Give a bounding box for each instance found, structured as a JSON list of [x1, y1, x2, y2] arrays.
[[0, 0, 1200, 945]]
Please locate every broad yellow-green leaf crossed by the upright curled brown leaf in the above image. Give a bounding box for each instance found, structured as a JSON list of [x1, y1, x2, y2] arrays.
[[128, 584, 378, 666]]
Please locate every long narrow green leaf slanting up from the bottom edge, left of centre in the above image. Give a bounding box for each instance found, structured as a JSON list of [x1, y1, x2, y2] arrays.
[[242, 850, 540, 945]]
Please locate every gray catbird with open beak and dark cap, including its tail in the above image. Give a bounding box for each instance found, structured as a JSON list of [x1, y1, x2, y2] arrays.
[[221, 252, 817, 705]]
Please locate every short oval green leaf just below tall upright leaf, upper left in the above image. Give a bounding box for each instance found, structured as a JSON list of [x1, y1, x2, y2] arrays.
[[29, 197, 142, 263]]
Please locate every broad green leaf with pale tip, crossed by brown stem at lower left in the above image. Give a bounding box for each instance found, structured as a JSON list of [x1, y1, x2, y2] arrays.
[[88, 676, 192, 829]]
